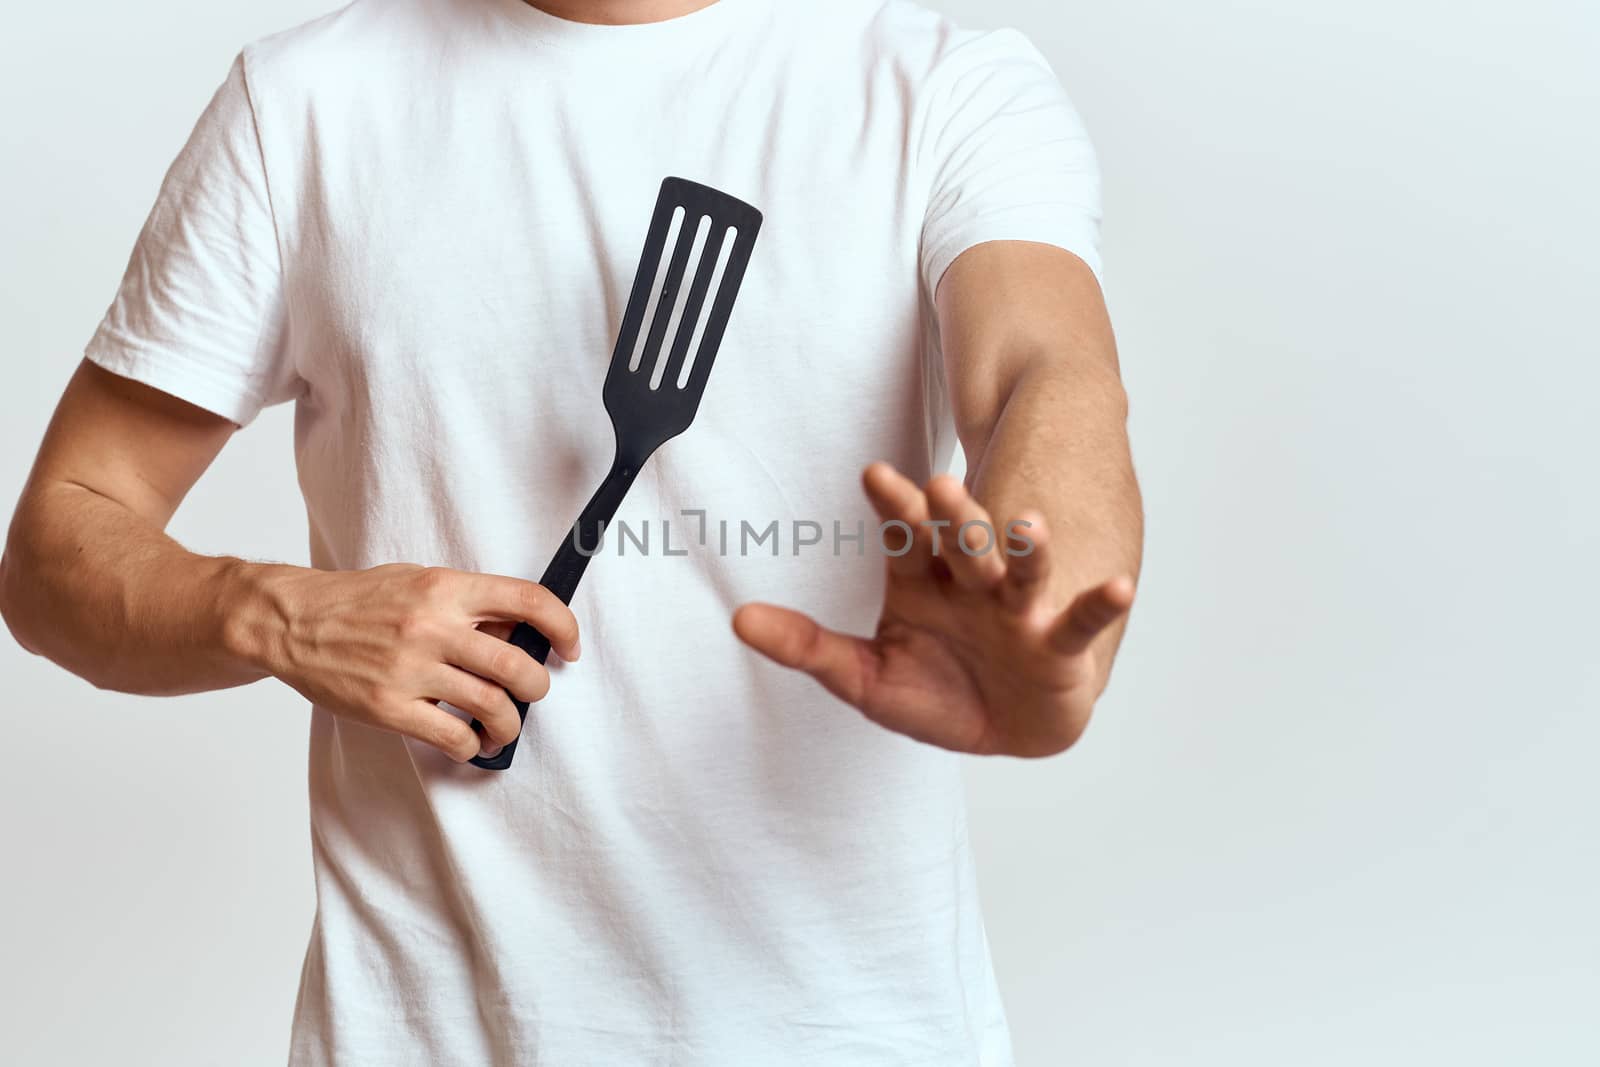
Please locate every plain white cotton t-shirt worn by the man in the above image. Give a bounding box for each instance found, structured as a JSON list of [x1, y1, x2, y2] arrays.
[[88, 0, 1099, 1067]]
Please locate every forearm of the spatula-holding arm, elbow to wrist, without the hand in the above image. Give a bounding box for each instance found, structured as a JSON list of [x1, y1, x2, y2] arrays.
[[0, 483, 269, 696]]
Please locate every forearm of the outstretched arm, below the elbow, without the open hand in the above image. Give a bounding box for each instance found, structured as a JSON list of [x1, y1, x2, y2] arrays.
[[968, 354, 1144, 670]]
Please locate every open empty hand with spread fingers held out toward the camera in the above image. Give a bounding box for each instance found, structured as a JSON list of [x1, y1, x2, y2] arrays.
[[734, 464, 1133, 757]]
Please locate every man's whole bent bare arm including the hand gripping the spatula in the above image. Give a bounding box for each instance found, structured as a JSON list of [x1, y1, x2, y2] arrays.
[[0, 363, 578, 760]]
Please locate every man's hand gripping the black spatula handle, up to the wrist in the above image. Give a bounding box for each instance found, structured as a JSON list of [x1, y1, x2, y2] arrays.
[[240, 563, 578, 763]]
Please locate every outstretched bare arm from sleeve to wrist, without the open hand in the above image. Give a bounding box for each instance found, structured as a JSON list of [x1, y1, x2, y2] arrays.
[[938, 242, 1144, 688]]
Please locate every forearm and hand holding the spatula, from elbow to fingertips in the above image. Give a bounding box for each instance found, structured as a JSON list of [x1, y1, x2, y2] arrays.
[[0, 467, 579, 763]]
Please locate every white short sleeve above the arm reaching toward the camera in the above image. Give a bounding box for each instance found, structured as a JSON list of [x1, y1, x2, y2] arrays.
[[918, 30, 1101, 298]]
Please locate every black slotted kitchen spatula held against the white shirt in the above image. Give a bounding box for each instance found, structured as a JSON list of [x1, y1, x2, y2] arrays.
[[472, 178, 762, 771]]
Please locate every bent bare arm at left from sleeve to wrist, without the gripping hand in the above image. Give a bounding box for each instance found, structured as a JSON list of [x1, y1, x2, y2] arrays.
[[0, 363, 251, 696]]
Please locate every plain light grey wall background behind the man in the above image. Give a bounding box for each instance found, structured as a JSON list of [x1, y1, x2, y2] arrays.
[[0, 0, 1600, 1067]]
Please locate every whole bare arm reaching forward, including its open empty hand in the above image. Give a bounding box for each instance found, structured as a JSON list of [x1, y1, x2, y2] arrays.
[[734, 242, 1142, 757]]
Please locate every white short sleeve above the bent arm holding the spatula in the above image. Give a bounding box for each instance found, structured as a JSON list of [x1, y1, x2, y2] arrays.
[[85, 56, 298, 426]]
